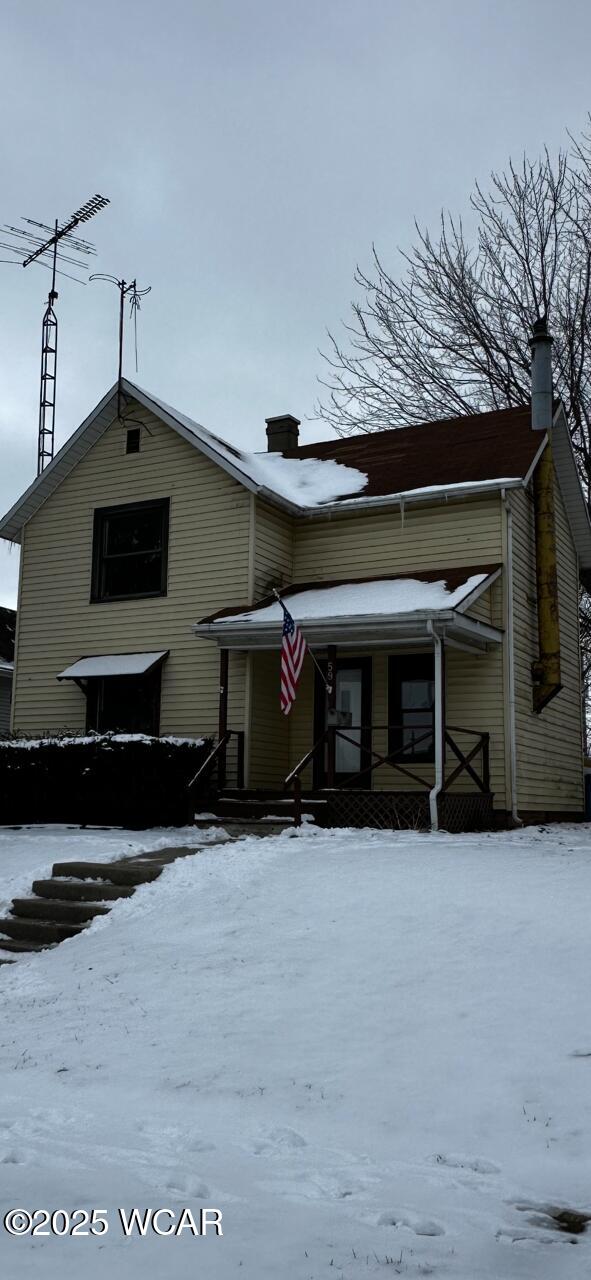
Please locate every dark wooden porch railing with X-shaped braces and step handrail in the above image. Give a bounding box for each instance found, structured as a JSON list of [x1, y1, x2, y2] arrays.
[[284, 724, 490, 827]]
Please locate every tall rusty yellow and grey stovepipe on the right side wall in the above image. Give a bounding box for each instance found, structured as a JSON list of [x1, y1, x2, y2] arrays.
[[530, 311, 563, 714]]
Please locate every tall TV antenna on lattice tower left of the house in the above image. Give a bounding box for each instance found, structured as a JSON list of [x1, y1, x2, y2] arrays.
[[0, 195, 110, 475]]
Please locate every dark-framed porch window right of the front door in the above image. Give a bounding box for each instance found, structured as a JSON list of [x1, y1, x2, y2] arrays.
[[388, 654, 435, 763]]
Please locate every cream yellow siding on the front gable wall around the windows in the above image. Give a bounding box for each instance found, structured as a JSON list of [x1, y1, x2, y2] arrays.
[[13, 408, 251, 735]]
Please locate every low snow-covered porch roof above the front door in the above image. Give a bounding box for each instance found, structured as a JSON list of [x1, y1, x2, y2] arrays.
[[193, 564, 503, 650]]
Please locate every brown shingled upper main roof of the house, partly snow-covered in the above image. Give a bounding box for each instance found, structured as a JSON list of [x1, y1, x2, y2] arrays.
[[0, 379, 591, 575]]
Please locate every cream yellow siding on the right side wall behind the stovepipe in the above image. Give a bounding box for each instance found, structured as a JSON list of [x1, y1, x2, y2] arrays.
[[510, 485, 583, 813]]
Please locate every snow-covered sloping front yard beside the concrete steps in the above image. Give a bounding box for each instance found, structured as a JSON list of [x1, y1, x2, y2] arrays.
[[0, 827, 591, 1280]]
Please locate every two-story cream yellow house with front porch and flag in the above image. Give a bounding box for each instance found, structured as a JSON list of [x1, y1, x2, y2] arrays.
[[0, 325, 591, 829]]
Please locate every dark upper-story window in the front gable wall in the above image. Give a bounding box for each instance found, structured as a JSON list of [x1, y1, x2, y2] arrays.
[[91, 498, 170, 600]]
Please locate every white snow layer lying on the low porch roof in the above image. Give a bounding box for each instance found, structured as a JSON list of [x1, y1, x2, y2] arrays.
[[193, 564, 500, 644]]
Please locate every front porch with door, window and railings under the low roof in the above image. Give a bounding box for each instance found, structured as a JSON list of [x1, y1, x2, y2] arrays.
[[196, 575, 504, 831]]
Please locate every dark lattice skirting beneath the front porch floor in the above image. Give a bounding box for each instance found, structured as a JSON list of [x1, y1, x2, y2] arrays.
[[321, 788, 495, 832]]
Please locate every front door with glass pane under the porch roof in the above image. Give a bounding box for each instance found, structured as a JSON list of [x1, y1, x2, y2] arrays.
[[313, 658, 371, 787]]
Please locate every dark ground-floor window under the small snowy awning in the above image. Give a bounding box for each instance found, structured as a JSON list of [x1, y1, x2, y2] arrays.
[[86, 667, 162, 737]]
